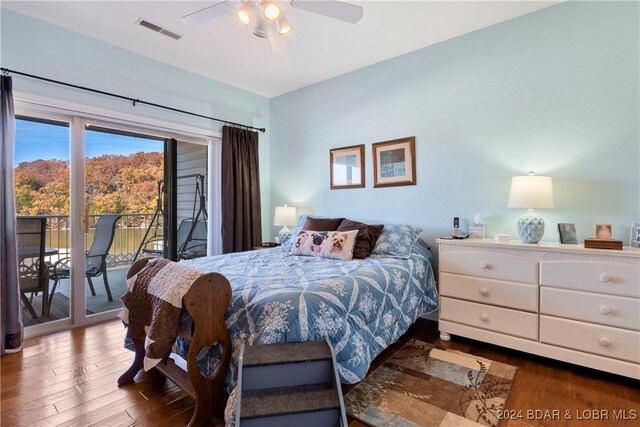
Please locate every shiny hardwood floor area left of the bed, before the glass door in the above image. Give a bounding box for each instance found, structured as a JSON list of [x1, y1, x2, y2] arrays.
[[0, 321, 194, 426]]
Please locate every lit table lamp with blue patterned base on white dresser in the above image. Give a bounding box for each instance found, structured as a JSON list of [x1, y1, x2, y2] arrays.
[[508, 172, 553, 243]]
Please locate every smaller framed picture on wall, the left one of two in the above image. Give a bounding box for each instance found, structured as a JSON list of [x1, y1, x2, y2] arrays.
[[329, 144, 364, 190]]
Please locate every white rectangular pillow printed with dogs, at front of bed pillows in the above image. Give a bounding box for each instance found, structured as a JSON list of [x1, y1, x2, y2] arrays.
[[290, 230, 358, 261]]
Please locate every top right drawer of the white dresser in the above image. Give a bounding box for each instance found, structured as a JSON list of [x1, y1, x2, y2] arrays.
[[540, 262, 640, 298]]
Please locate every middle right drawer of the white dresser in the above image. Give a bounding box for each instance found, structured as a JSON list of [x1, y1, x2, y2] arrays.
[[540, 286, 640, 331]]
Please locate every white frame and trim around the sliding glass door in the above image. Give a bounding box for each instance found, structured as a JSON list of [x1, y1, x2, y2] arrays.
[[14, 92, 222, 338]]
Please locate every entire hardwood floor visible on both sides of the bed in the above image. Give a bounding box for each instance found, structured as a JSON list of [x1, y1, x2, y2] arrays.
[[0, 319, 640, 427]]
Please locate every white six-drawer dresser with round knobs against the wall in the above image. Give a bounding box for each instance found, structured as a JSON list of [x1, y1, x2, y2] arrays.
[[438, 239, 640, 379]]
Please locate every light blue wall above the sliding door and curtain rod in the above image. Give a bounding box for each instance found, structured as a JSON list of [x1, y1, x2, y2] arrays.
[[0, 9, 272, 237]]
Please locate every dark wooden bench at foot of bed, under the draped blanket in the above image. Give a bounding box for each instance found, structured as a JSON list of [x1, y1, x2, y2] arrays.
[[118, 258, 231, 427]]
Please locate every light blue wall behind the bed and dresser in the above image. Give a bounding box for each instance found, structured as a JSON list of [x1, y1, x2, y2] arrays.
[[271, 2, 640, 244]]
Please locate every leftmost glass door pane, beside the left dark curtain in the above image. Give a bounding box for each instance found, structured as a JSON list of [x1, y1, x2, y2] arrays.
[[14, 114, 72, 327]]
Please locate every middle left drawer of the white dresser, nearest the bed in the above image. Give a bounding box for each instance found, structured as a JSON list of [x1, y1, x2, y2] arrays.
[[439, 273, 538, 311]]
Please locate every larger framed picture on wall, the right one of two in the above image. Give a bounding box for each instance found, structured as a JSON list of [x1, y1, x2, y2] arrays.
[[373, 136, 416, 188]]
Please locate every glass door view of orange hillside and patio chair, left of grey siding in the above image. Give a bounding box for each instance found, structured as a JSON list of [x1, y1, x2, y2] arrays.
[[84, 125, 164, 315]]
